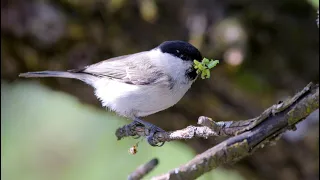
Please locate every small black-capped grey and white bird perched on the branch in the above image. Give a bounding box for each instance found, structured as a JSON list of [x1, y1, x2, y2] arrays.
[[19, 40, 202, 146]]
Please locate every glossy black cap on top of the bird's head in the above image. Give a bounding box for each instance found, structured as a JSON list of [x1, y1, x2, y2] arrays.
[[159, 41, 202, 61]]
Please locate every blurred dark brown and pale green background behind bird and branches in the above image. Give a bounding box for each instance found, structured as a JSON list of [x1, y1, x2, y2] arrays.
[[1, 0, 319, 180]]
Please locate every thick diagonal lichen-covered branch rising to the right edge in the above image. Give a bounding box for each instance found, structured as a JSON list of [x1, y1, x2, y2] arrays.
[[153, 84, 319, 180]]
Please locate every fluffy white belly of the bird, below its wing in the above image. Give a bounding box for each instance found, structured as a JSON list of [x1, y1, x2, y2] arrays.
[[96, 81, 191, 118]]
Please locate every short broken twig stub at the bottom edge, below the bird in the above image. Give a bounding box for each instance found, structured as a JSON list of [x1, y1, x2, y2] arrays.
[[128, 158, 159, 180]]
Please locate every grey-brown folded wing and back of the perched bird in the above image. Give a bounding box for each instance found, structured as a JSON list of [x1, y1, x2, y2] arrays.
[[70, 52, 172, 86]]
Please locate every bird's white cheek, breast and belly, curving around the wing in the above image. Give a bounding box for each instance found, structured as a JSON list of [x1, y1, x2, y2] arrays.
[[94, 50, 193, 118]]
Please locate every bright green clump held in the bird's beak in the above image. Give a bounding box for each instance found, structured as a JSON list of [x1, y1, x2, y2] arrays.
[[193, 58, 219, 79]]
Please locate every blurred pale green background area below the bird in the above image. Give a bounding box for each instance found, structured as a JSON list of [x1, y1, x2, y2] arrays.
[[1, 82, 245, 180]]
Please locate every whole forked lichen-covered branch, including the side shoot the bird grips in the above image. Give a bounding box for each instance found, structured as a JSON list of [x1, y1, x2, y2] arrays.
[[121, 83, 319, 180]]
